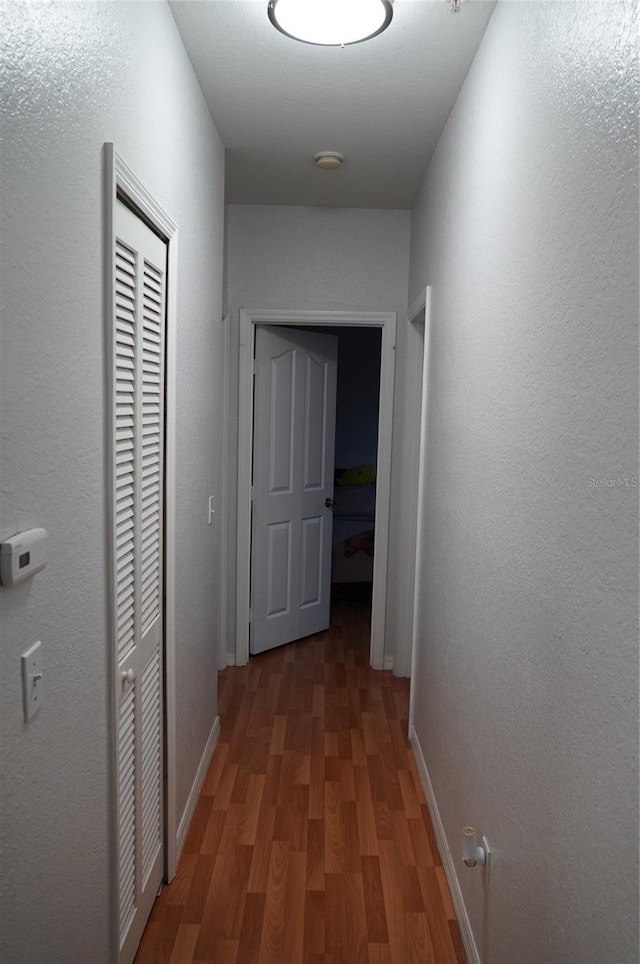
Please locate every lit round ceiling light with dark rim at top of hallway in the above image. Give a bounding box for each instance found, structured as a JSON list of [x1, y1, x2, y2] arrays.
[[267, 0, 393, 47]]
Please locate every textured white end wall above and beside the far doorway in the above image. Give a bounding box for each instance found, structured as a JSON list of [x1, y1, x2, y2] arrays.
[[227, 205, 410, 656]]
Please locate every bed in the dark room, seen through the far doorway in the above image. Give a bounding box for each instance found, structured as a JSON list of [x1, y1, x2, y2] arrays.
[[331, 466, 376, 583]]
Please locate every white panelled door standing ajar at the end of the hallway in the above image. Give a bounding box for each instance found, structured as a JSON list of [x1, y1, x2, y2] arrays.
[[250, 325, 338, 654]]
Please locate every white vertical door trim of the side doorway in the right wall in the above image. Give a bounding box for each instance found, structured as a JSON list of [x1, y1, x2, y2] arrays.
[[409, 287, 431, 731]]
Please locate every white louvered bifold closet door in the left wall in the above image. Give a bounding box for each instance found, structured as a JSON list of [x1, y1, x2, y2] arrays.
[[113, 201, 167, 964]]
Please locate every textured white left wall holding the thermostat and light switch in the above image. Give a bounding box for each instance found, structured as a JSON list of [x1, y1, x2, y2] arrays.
[[0, 3, 224, 964]]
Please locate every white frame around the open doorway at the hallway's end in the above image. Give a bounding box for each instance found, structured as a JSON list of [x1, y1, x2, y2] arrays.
[[235, 308, 396, 669]]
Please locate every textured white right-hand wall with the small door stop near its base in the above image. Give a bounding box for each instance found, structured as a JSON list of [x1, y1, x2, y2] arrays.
[[410, 2, 638, 964]]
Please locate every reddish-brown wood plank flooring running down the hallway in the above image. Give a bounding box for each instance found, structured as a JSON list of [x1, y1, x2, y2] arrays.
[[136, 602, 466, 964]]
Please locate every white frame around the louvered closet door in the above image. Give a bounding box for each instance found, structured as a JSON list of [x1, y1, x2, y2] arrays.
[[104, 143, 179, 960]]
